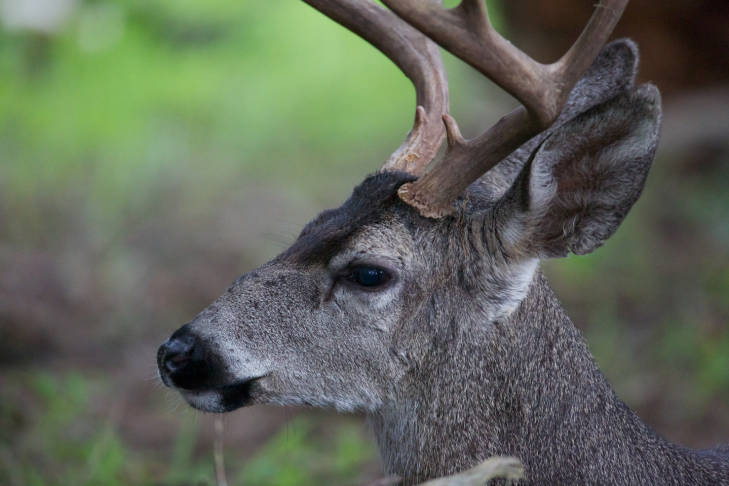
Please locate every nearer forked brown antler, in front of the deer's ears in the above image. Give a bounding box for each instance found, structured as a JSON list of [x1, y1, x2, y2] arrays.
[[383, 0, 628, 217]]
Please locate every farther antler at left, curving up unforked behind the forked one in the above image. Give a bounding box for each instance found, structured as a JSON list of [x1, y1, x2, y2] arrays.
[[304, 0, 448, 176]]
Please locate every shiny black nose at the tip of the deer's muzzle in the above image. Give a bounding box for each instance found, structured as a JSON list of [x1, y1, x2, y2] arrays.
[[157, 325, 210, 390]]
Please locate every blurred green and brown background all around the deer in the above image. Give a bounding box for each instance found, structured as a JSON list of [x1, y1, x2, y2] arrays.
[[0, 0, 729, 486]]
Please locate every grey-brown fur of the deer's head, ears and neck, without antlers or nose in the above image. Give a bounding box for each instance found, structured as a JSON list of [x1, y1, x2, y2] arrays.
[[162, 41, 729, 485]]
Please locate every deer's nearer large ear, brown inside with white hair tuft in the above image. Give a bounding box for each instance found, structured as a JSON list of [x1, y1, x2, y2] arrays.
[[504, 85, 661, 257]]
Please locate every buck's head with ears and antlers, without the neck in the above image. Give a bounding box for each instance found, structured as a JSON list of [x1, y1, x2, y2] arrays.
[[158, 0, 660, 412]]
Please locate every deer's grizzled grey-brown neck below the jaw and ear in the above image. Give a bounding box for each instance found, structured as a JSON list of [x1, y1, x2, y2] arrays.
[[371, 272, 729, 484]]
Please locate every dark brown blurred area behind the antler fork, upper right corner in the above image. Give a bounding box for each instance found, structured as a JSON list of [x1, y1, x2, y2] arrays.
[[502, 0, 729, 97]]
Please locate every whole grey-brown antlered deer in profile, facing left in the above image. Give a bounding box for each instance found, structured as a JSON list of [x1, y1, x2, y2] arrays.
[[157, 0, 729, 485]]
